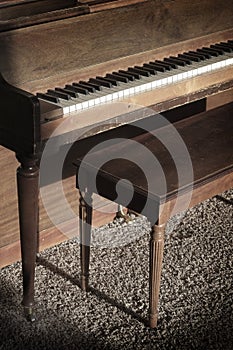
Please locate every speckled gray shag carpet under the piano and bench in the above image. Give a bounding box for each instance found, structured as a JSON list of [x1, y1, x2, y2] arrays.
[[0, 191, 233, 350]]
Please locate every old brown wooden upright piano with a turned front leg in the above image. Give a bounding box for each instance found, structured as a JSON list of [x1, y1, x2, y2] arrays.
[[0, 0, 233, 320]]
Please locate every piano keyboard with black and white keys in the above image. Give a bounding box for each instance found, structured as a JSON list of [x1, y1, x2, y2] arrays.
[[37, 40, 233, 115]]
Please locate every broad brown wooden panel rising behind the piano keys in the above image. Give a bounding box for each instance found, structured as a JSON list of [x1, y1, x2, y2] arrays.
[[0, 0, 233, 86]]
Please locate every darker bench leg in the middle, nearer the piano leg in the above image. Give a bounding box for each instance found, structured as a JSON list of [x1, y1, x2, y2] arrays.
[[79, 191, 92, 291]]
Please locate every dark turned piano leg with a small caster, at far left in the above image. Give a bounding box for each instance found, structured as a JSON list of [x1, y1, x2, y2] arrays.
[[17, 157, 39, 321]]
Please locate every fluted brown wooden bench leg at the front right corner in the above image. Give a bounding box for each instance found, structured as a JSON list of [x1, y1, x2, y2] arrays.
[[149, 225, 165, 328]]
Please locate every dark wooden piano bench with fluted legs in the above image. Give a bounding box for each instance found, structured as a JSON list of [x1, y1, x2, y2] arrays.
[[75, 103, 233, 328]]
